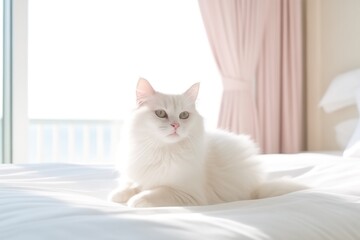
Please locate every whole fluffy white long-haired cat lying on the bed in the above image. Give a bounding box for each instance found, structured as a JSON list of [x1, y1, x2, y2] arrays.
[[110, 79, 305, 207]]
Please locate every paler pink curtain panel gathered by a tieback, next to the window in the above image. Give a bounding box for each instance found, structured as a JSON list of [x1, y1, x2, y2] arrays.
[[199, 0, 268, 140]]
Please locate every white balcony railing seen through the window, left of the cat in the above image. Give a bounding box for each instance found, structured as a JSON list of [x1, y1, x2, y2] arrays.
[[28, 119, 122, 163]]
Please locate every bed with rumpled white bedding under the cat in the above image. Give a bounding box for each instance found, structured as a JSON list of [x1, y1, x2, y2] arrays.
[[0, 153, 360, 240]]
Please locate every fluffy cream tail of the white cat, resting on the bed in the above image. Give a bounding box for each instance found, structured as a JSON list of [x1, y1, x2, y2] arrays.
[[253, 178, 309, 199]]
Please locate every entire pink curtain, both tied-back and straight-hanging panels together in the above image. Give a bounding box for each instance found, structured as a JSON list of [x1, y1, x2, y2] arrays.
[[199, 0, 303, 153]]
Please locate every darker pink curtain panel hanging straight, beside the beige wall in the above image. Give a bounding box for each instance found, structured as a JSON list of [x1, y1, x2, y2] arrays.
[[257, 0, 304, 153]]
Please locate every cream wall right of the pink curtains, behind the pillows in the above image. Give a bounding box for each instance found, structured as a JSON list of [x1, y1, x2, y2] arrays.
[[305, 0, 360, 150]]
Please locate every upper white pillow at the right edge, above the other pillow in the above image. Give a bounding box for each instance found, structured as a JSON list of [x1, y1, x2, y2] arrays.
[[319, 68, 360, 113]]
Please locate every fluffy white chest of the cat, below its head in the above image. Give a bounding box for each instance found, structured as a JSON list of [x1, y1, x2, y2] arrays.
[[125, 139, 205, 191]]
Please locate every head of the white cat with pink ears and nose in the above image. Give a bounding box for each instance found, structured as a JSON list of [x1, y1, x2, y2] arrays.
[[135, 79, 203, 143]]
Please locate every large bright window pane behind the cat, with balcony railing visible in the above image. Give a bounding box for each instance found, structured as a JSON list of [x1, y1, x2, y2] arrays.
[[6, 0, 221, 162]]
